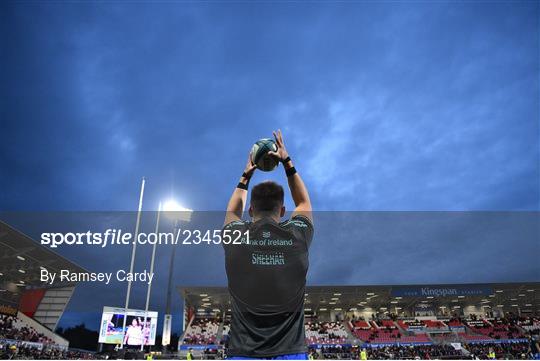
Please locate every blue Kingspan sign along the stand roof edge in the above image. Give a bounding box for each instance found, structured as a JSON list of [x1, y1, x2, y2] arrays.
[[392, 286, 493, 297]]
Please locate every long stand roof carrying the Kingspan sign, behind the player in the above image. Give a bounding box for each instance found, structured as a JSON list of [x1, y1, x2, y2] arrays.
[[178, 282, 540, 314]]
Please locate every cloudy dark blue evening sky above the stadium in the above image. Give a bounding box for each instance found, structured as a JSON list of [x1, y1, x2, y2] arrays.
[[0, 1, 540, 327]]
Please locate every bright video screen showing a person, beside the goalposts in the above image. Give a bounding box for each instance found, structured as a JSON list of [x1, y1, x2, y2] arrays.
[[99, 307, 158, 346]]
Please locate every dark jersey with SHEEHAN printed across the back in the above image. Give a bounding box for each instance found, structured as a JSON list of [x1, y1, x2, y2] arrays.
[[224, 215, 313, 357]]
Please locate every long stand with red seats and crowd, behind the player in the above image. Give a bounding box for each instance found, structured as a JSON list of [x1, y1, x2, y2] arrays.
[[179, 283, 540, 359]]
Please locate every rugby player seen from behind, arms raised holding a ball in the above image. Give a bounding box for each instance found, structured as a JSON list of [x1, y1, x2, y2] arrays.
[[223, 130, 313, 360]]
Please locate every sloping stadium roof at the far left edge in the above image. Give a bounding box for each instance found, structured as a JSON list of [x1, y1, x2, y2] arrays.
[[0, 221, 85, 305]]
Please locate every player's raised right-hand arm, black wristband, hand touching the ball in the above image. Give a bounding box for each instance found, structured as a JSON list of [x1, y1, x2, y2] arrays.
[[270, 130, 313, 222]]
